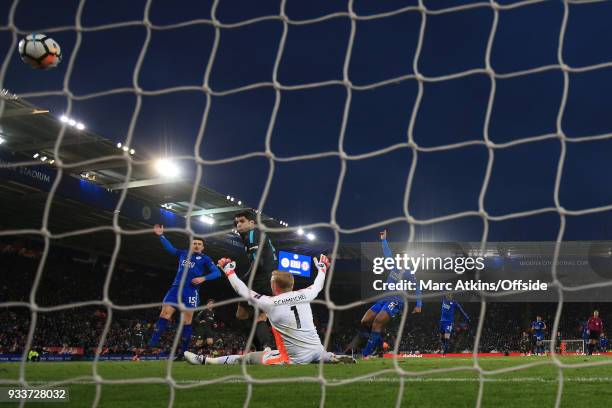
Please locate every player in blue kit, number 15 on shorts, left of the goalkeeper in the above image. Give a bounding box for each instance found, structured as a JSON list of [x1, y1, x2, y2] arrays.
[[149, 225, 221, 359]]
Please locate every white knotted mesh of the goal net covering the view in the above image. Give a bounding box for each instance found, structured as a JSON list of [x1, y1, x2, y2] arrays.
[[0, 0, 612, 407]]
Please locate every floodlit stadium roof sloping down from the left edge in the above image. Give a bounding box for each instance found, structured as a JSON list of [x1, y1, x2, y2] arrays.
[[1, 95, 282, 230]]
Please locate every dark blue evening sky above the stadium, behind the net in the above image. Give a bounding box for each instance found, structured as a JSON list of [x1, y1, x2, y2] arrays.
[[0, 0, 612, 241]]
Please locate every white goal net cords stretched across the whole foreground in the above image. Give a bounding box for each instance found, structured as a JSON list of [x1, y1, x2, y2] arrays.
[[0, 0, 612, 407]]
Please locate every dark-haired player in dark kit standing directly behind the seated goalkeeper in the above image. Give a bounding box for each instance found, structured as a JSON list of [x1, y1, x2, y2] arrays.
[[234, 210, 278, 350]]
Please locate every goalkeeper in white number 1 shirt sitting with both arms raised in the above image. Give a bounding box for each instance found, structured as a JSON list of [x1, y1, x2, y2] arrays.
[[185, 255, 355, 365]]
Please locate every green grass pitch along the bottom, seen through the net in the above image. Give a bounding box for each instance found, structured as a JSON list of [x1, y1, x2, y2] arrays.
[[0, 356, 612, 408]]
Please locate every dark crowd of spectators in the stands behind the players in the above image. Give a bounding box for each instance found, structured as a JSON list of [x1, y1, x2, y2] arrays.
[[0, 241, 612, 355]]
